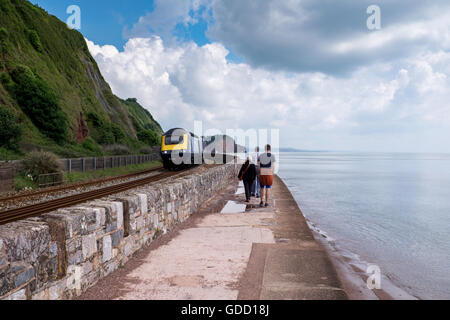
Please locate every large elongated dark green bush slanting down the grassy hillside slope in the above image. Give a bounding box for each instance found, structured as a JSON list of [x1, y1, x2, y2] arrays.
[[12, 66, 68, 143]]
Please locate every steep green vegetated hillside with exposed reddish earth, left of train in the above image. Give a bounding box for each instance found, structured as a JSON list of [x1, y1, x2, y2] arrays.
[[0, 0, 163, 160]]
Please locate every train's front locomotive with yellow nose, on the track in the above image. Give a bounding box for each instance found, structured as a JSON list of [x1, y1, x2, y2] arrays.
[[161, 128, 205, 170]]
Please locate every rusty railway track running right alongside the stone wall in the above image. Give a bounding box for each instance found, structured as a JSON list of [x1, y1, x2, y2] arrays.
[[0, 169, 180, 225]]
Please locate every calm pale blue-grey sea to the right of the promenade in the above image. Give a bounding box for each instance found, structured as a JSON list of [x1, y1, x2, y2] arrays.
[[278, 152, 450, 299]]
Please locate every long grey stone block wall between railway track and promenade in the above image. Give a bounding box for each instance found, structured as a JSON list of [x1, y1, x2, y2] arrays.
[[0, 164, 236, 300]]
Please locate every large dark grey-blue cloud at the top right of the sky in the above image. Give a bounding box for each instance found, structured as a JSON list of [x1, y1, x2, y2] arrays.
[[208, 0, 450, 74]]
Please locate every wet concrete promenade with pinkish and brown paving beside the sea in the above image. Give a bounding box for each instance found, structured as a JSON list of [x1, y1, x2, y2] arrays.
[[79, 178, 347, 300]]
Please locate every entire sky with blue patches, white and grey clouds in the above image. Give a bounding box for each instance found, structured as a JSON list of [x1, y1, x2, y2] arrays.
[[32, 0, 450, 152]]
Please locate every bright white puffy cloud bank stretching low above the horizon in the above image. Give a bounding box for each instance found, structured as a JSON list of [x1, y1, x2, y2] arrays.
[[87, 36, 450, 150]]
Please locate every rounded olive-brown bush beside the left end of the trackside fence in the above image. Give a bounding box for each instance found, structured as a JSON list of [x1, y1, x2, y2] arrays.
[[20, 151, 62, 182]]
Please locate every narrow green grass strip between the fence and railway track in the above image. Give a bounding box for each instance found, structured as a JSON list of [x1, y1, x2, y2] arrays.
[[64, 161, 161, 183]]
